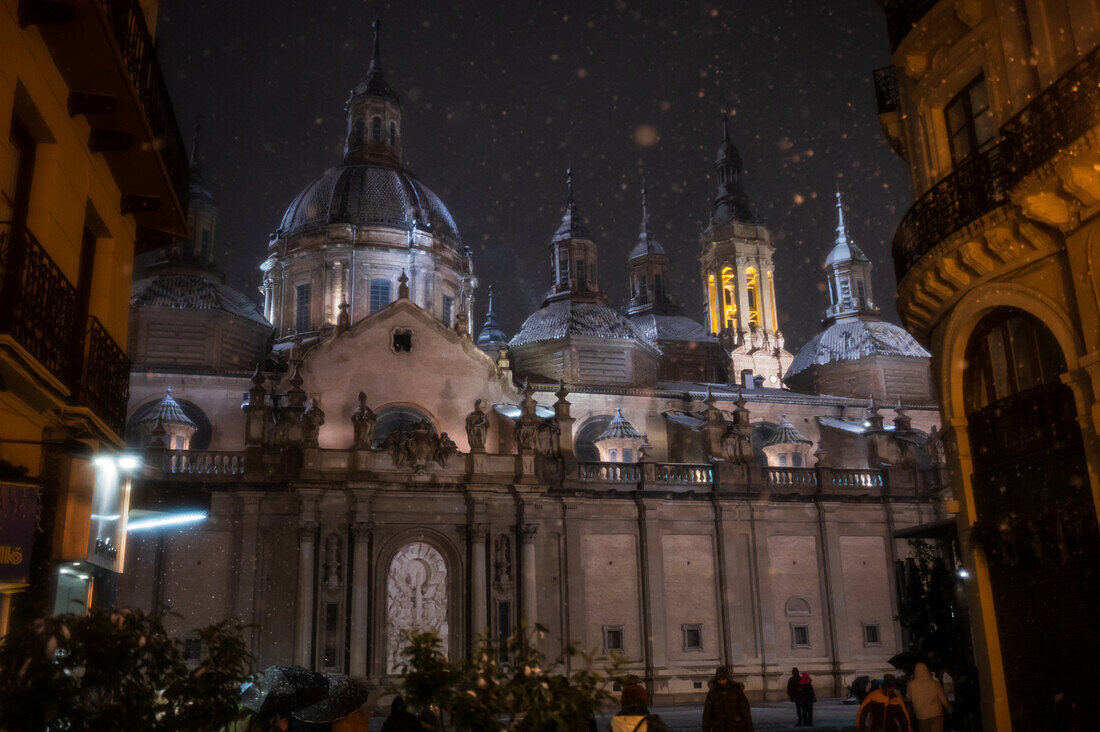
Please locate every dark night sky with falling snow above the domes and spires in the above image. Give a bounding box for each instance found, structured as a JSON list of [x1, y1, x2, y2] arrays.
[[158, 0, 911, 350]]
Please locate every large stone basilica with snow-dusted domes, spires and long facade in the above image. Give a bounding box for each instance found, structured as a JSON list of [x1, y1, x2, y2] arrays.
[[119, 21, 947, 703]]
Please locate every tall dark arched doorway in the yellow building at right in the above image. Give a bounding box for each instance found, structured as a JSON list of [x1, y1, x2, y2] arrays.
[[965, 308, 1100, 730]]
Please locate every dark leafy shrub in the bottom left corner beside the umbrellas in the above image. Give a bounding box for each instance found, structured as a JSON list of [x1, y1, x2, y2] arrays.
[[0, 610, 251, 732]]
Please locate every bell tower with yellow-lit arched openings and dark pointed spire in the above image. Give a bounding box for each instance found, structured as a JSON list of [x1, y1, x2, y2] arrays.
[[699, 117, 793, 387]]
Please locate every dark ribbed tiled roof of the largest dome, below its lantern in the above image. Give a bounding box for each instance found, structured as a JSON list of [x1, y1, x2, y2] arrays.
[[278, 165, 462, 247]]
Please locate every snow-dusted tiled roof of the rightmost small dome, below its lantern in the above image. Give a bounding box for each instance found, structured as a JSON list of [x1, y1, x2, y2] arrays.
[[783, 318, 932, 379]]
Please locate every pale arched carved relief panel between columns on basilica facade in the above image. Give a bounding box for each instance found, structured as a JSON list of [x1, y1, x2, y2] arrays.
[[386, 542, 450, 674]]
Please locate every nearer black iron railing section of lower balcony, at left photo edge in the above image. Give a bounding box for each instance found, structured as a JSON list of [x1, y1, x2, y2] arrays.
[[0, 221, 78, 384]]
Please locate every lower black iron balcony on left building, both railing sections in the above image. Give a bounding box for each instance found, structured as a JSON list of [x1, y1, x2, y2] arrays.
[[0, 221, 130, 436]]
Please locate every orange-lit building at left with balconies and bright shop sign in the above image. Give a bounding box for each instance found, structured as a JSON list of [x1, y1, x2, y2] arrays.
[[0, 0, 188, 622]]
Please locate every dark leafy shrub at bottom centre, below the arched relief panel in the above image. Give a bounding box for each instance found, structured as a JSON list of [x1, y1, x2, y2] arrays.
[[393, 625, 624, 732]]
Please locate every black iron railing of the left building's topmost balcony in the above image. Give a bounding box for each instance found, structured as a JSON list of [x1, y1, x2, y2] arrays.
[[99, 0, 190, 211]]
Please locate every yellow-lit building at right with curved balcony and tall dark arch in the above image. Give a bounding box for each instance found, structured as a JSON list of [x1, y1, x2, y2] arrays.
[[876, 0, 1100, 730]]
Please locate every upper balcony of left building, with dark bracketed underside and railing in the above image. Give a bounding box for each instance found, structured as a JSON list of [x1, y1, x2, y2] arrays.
[[19, 0, 190, 241]]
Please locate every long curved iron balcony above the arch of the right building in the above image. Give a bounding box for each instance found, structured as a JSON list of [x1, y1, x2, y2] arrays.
[[893, 46, 1100, 283]]
